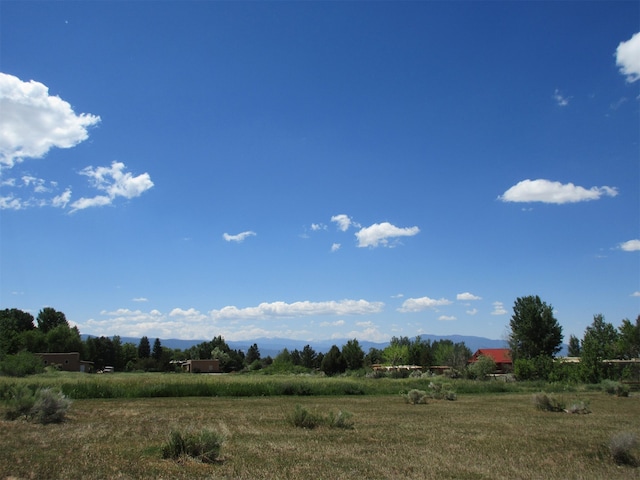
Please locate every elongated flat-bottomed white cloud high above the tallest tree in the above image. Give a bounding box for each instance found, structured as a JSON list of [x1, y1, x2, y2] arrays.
[[498, 179, 618, 204]]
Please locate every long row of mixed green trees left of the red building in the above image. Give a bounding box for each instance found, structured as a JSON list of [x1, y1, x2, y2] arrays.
[[0, 307, 471, 375]]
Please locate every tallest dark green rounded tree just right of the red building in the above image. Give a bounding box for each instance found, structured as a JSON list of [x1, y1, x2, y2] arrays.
[[509, 295, 562, 362]]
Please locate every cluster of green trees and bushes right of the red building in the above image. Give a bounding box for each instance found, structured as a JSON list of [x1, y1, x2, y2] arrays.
[[509, 296, 640, 383]]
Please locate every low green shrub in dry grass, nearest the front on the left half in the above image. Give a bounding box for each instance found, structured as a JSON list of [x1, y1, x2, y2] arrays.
[[162, 429, 224, 463]]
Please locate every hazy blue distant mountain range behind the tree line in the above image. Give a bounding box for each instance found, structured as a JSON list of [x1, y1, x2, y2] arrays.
[[82, 335, 508, 357]]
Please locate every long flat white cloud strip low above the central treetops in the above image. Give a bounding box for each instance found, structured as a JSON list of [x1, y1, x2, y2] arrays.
[[209, 300, 384, 320]]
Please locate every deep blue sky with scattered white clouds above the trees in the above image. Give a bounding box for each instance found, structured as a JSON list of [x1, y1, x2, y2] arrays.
[[0, 0, 640, 341]]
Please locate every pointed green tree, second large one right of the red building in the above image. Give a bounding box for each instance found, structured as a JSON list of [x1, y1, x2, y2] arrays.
[[580, 314, 618, 383]]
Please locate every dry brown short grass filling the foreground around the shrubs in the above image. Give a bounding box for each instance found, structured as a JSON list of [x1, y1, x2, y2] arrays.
[[0, 393, 640, 480]]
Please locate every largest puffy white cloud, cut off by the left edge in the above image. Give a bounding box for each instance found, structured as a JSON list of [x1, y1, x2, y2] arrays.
[[0, 73, 100, 168]]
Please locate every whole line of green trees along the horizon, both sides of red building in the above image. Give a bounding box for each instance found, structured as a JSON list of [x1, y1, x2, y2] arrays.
[[0, 296, 640, 383]]
